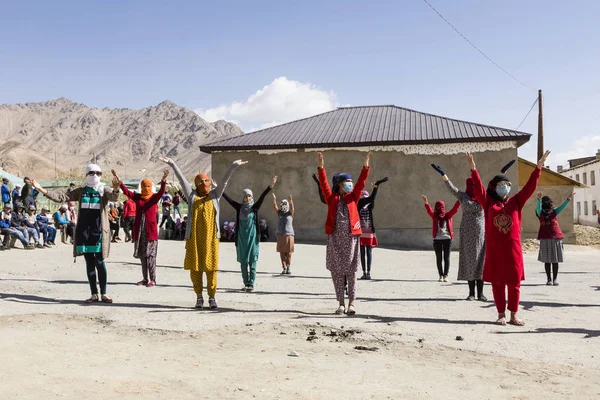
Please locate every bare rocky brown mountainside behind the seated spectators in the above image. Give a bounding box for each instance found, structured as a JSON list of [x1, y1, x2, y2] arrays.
[[0, 98, 243, 180]]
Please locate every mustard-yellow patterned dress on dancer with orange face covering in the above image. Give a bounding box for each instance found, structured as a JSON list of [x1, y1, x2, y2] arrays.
[[183, 196, 219, 272]]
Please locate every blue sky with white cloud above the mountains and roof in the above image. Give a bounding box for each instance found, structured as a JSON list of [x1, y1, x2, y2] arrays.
[[0, 0, 600, 167]]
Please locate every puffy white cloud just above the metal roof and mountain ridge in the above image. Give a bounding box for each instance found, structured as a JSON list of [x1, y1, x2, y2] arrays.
[[194, 76, 338, 132]]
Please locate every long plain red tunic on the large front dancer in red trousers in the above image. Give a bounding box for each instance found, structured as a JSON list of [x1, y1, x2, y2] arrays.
[[471, 168, 542, 285]]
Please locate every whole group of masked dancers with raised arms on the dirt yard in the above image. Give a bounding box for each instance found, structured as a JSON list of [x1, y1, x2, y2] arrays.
[[33, 151, 568, 325]]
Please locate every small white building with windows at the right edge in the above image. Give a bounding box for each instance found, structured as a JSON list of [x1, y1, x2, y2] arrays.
[[557, 150, 600, 226]]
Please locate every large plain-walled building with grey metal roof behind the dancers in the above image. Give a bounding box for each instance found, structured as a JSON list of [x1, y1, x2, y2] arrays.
[[200, 106, 533, 248]]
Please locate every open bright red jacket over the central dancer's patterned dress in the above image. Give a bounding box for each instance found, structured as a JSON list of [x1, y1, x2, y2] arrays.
[[318, 167, 369, 235]]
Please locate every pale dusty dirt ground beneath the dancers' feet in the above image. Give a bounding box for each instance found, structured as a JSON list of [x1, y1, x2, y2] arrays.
[[0, 241, 600, 400]]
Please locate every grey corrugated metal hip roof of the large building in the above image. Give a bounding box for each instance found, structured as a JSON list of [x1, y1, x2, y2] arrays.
[[200, 106, 531, 153]]
